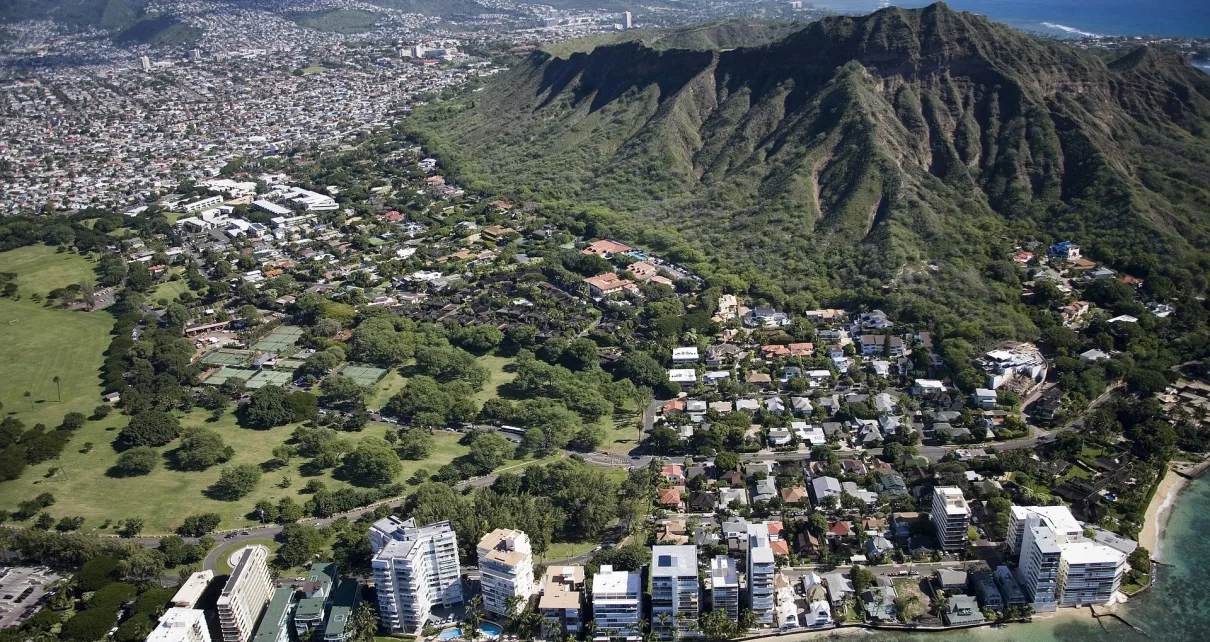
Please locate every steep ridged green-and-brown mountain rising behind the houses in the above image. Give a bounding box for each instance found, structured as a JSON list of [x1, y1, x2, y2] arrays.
[[413, 4, 1210, 287]]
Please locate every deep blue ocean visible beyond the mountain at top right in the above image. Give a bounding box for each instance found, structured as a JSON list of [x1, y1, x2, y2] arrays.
[[808, 0, 1210, 37]]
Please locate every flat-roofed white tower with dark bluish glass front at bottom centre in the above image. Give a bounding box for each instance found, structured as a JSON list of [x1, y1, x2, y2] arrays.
[[651, 545, 702, 640]]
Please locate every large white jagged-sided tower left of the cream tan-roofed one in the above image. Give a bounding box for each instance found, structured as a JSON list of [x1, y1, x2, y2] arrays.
[[370, 516, 462, 634]]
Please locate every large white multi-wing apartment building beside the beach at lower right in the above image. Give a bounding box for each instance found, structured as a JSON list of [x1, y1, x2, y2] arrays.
[[1009, 507, 1128, 612]]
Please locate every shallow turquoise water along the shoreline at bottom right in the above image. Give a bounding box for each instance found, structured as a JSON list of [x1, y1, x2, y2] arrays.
[[845, 478, 1210, 642]]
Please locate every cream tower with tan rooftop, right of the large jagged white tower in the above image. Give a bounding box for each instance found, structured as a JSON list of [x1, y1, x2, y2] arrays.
[[478, 528, 534, 617]]
